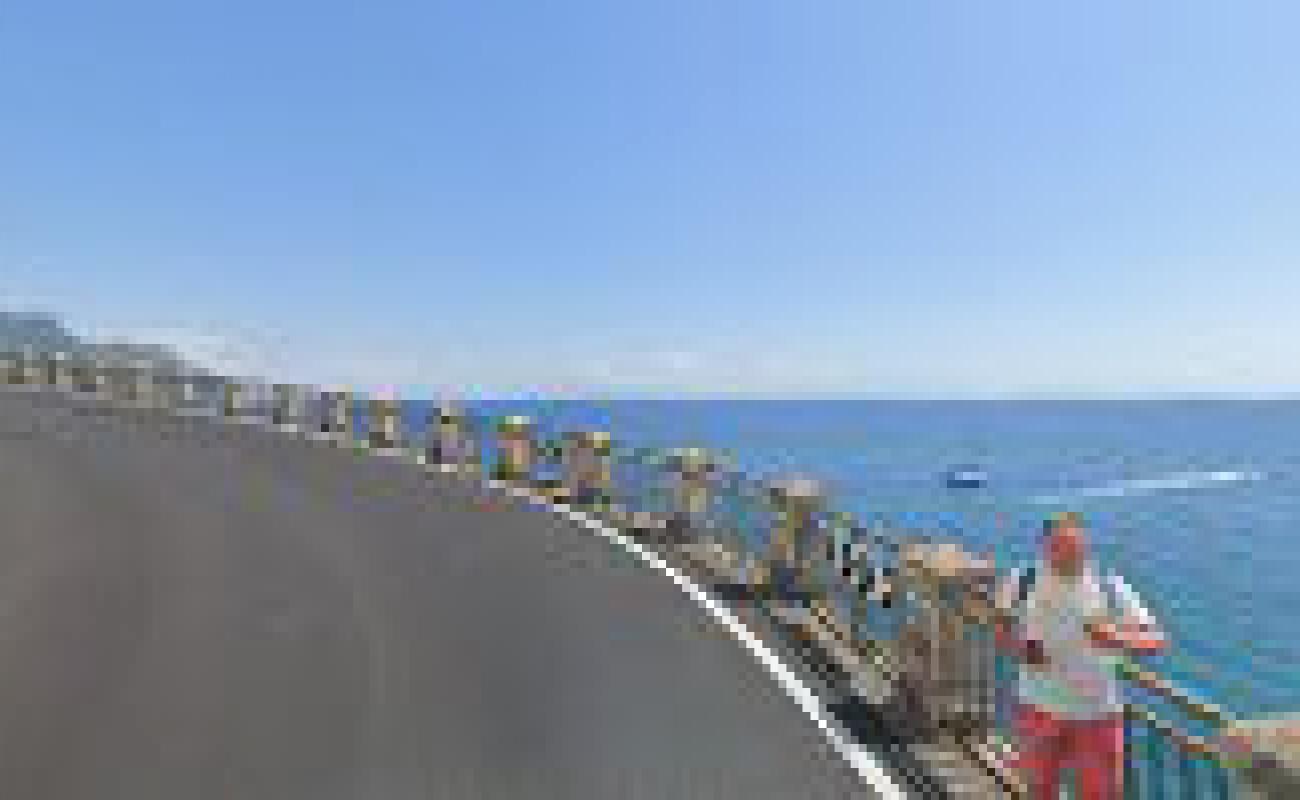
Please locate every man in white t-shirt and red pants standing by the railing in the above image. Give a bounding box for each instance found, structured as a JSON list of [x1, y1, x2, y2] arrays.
[[997, 513, 1167, 800]]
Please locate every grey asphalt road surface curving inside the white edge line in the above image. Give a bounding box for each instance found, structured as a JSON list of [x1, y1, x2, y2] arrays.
[[0, 392, 881, 800]]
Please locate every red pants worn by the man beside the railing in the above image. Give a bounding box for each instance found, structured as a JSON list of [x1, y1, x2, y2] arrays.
[[1015, 705, 1125, 800]]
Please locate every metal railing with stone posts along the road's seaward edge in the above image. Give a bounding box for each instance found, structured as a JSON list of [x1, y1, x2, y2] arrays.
[[0, 351, 1282, 800]]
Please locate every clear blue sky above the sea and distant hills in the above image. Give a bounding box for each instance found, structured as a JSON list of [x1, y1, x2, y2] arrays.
[[0, 0, 1300, 395]]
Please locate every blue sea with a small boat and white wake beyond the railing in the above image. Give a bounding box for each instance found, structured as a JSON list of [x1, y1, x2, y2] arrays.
[[400, 399, 1300, 715]]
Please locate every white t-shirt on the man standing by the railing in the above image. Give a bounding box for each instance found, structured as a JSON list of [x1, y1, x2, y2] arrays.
[[1009, 565, 1151, 719]]
